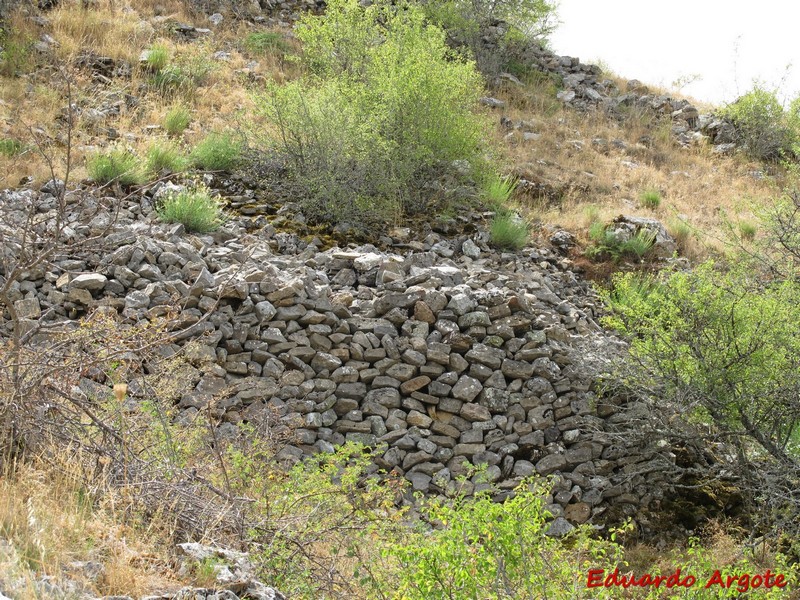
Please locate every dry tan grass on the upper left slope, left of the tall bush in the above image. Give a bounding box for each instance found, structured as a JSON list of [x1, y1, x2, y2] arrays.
[[0, 0, 298, 188]]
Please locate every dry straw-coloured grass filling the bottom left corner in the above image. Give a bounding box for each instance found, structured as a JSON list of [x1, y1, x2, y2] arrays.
[[0, 456, 179, 599]]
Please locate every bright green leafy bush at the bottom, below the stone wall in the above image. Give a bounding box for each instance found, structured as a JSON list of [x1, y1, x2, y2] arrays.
[[377, 480, 622, 600]]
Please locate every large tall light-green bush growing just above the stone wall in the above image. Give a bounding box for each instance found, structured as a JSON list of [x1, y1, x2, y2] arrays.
[[261, 0, 485, 229]]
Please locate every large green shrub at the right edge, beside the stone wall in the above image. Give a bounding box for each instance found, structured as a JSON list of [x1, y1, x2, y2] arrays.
[[607, 261, 800, 472]]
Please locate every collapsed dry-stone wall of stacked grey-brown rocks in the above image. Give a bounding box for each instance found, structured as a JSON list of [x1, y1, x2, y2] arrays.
[[0, 182, 692, 523]]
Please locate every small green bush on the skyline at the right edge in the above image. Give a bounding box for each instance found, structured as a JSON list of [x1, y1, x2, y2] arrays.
[[720, 85, 800, 160]]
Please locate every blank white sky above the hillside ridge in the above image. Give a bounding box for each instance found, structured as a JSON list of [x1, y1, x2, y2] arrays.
[[551, 0, 800, 104]]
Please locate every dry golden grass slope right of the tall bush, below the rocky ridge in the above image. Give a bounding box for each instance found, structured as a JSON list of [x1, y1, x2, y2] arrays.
[[494, 79, 776, 256]]
